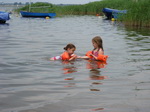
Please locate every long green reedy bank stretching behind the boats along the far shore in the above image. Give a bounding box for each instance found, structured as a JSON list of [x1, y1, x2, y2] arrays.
[[17, 0, 150, 27]]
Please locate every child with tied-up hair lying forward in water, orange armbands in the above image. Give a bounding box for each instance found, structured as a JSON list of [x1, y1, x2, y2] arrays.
[[50, 43, 77, 61]]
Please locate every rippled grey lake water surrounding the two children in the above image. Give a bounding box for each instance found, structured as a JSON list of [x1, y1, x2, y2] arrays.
[[0, 6, 150, 112]]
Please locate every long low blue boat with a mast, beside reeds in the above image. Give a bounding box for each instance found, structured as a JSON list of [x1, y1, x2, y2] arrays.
[[20, 11, 56, 18]]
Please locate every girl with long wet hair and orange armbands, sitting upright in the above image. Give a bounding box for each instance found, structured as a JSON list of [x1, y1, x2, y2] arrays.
[[80, 36, 108, 62]]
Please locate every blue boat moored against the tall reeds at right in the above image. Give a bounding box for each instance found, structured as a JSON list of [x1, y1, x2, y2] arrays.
[[102, 8, 127, 20]]
